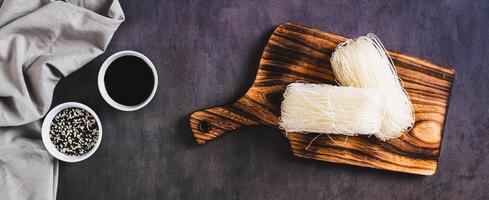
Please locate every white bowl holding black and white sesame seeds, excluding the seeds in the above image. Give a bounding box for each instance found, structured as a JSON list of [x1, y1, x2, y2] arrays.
[[41, 102, 102, 162]]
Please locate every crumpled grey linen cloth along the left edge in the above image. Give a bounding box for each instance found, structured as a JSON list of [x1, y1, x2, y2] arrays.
[[0, 0, 124, 200]]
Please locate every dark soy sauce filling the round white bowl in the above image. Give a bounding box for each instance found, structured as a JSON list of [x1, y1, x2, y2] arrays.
[[104, 56, 156, 106]]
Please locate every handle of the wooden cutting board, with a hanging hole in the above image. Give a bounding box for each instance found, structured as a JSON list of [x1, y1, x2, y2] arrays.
[[190, 101, 258, 144]]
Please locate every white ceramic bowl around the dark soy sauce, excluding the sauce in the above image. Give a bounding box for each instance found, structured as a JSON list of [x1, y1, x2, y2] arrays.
[[98, 50, 158, 111]]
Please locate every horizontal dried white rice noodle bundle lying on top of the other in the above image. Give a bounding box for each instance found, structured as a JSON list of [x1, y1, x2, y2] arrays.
[[279, 83, 384, 136]]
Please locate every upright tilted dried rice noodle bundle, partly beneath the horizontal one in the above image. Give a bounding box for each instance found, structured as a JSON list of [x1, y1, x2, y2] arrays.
[[331, 34, 414, 141]]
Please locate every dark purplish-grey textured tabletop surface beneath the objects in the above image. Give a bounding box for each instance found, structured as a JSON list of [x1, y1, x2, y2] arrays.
[[53, 0, 489, 200]]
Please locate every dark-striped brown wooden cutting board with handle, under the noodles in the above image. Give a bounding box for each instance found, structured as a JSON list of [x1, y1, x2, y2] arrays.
[[190, 23, 455, 175]]
